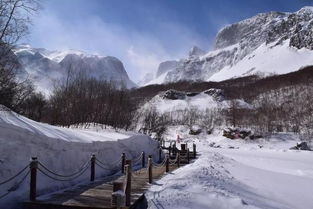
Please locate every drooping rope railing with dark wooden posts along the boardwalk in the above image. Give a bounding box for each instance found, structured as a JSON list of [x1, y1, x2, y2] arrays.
[[0, 146, 195, 204]]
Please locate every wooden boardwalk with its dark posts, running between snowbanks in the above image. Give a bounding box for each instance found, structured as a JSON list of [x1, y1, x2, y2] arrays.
[[23, 145, 196, 209]]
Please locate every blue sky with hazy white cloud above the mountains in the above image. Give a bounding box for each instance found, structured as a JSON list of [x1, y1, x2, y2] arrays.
[[23, 0, 313, 82]]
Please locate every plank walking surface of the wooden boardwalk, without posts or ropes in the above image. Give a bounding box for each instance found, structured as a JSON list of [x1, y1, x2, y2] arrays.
[[24, 165, 177, 209]]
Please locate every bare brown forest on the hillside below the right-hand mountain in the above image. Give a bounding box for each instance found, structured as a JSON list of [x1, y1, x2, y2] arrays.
[[134, 67, 313, 138]]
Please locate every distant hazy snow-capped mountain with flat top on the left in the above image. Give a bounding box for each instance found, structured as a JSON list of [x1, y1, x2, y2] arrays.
[[14, 45, 136, 94]]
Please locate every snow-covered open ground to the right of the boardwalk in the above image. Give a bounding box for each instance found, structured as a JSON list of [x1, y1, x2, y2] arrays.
[[146, 128, 313, 209]]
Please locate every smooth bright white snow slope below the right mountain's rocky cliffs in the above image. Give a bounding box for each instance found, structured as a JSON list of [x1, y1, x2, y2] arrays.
[[208, 40, 313, 81]]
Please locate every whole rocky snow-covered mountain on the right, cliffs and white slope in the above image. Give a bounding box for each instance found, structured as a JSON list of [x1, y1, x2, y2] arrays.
[[146, 7, 313, 85]]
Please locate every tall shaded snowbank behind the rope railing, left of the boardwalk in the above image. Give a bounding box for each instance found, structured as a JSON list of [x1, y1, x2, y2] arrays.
[[0, 107, 158, 209]]
